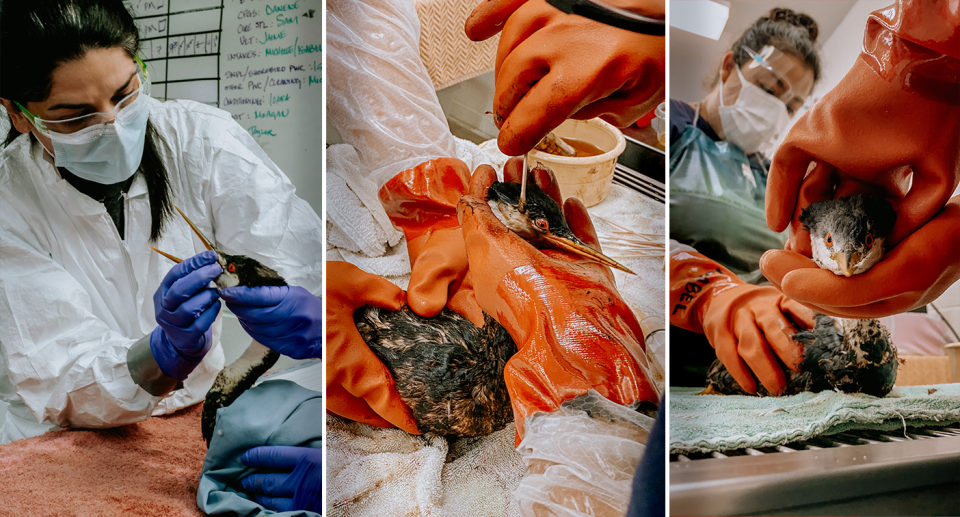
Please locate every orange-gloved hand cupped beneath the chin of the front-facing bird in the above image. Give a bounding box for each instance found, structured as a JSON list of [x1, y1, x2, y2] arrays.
[[760, 196, 960, 318]]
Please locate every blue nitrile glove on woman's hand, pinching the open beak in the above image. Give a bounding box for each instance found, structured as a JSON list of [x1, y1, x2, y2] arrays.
[[150, 251, 222, 379]]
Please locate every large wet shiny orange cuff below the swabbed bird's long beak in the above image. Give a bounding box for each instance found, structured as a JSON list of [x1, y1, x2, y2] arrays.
[[495, 264, 659, 444]]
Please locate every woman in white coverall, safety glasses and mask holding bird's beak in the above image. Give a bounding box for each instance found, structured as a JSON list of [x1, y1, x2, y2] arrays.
[[0, 0, 323, 454]]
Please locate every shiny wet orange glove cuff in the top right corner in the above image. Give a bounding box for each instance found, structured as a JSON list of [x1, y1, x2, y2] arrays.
[[860, 0, 960, 105]]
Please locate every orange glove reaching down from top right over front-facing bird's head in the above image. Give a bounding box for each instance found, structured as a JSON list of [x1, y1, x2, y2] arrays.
[[762, 0, 960, 317]]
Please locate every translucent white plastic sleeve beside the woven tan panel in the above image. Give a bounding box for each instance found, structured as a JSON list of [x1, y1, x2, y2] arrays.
[[327, 0, 456, 188]]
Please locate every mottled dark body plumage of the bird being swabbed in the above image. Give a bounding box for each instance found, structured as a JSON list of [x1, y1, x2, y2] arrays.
[[354, 306, 517, 436]]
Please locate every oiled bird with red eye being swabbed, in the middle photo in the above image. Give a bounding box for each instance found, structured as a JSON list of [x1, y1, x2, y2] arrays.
[[354, 177, 629, 437]]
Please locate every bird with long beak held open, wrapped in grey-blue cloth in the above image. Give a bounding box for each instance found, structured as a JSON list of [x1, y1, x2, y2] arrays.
[[153, 207, 287, 445]]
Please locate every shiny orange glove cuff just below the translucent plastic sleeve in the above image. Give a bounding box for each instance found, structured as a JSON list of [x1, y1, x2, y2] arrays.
[[379, 158, 470, 241]]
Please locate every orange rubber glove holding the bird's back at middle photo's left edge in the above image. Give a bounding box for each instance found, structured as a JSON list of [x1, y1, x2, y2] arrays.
[[325, 262, 420, 434]]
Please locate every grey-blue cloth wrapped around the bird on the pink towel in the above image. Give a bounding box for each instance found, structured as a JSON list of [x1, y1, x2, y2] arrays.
[[197, 380, 323, 517]]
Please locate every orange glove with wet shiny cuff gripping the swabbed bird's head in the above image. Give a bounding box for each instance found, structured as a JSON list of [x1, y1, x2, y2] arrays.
[[458, 164, 659, 444]]
